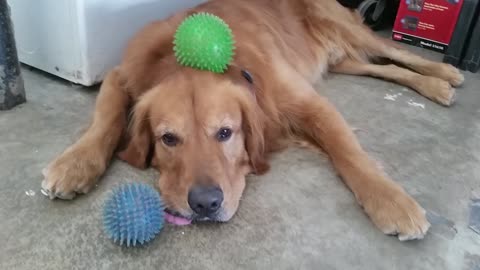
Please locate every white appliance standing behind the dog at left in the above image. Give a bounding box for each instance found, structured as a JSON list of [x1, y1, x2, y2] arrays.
[[8, 0, 205, 86]]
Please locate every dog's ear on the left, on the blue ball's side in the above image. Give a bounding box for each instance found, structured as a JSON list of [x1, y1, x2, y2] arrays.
[[117, 96, 152, 169]]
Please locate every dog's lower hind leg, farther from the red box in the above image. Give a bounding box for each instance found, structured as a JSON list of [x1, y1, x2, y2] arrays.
[[330, 59, 455, 106]]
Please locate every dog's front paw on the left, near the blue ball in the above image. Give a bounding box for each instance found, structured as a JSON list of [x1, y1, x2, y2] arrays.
[[42, 146, 105, 200]]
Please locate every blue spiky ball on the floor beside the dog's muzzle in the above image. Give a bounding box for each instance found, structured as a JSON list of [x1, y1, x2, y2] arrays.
[[103, 183, 165, 247]]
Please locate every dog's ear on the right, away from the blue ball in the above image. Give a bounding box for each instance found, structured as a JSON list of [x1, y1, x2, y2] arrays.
[[242, 97, 270, 174]]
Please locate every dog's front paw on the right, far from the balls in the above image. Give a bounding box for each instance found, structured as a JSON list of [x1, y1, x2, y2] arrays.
[[361, 183, 430, 241]]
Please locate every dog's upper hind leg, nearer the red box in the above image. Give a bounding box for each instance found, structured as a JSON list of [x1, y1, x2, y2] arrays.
[[300, 0, 464, 87]]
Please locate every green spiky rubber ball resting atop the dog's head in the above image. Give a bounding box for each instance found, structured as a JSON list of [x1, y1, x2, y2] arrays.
[[173, 13, 235, 73]]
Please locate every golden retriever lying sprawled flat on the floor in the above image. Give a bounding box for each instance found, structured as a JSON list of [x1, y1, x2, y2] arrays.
[[42, 0, 464, 240]]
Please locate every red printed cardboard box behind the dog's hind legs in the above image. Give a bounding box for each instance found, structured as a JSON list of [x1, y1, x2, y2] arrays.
[[392, 0, 463, 53]]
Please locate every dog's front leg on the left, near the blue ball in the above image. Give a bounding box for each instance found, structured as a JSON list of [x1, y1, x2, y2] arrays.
[[42, 69, 129, 199]]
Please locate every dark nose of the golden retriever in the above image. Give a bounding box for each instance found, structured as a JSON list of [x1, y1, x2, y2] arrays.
[[188, 185, 223, 217]]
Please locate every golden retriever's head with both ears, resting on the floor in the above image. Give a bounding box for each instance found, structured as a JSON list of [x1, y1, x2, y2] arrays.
[[119, 68, 268, 224]]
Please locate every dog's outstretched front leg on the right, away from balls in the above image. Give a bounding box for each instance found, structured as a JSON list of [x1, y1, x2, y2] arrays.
[[278, 81, 430, 240]]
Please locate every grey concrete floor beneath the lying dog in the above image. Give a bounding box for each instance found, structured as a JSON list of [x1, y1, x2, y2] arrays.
[[0, 48, 480, 270]]
